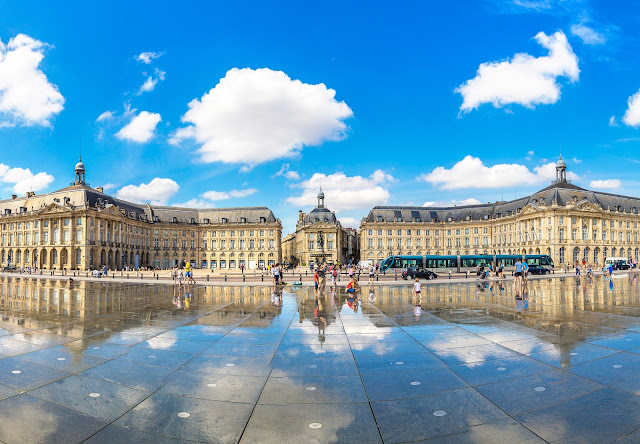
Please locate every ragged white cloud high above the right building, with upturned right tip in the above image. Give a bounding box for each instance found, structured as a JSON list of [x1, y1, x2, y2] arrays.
[[455, 31, 580, 112]]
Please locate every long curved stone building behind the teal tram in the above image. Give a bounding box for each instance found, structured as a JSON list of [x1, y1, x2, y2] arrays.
[[360, 158, 640, 265]]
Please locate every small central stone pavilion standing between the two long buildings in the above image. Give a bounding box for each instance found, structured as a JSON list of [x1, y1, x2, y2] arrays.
[[283, 190, 358, 266]]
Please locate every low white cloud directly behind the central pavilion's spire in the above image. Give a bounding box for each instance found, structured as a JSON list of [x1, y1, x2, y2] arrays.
[[286, 170, 395, 212]]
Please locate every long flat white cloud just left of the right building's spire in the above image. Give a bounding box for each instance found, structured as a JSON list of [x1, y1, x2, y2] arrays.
[[419, 156, 578, 190]]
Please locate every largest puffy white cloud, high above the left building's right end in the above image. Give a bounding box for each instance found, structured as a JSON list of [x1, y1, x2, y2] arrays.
[[170, 68, 353, 165]]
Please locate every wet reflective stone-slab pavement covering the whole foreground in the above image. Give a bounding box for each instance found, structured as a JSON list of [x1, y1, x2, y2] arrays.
[[0, 274, 640, 443]]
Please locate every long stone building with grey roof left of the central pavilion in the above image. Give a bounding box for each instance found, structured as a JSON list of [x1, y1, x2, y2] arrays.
[[0, 161, 282, 271]]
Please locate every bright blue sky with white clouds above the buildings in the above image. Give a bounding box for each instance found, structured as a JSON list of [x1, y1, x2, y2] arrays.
[[0, 0, 640, 232]]
